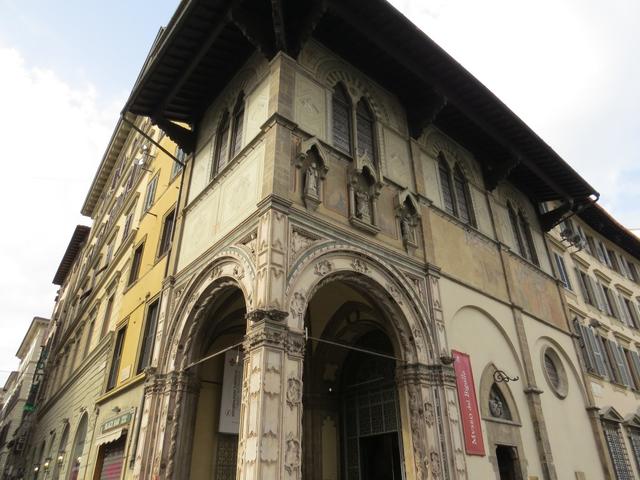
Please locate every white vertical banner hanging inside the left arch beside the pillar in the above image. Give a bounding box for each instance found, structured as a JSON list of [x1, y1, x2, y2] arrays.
[[218, 350, 243, 435]]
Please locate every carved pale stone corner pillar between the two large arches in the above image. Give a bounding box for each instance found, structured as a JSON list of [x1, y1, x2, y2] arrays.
[[237, 309, 304, 480]]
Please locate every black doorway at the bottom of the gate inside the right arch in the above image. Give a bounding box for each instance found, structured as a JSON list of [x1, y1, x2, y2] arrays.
[[360, 432, 402, 480]]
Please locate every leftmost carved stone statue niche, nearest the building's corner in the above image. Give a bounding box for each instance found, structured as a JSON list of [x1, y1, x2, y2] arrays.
[[296, 137, 329, 210]]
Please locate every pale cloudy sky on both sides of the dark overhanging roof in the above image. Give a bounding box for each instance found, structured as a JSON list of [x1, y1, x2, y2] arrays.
[[0, 0, 640, 385]]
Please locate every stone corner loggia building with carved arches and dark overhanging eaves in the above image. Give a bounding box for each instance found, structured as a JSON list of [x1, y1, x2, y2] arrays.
[[15, 0, 640, 480]]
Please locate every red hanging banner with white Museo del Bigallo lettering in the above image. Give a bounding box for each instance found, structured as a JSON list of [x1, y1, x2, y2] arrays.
[[451, 350, 484, 456]]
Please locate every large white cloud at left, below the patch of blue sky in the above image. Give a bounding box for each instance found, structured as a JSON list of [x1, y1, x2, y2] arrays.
[[0, 45, 122, 382]]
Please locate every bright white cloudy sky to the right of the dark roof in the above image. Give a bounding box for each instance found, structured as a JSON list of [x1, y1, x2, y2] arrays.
[[391, 0, 640, 227]]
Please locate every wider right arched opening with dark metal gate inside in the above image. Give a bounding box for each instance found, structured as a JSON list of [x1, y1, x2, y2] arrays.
[[303, 280, 404, 480]]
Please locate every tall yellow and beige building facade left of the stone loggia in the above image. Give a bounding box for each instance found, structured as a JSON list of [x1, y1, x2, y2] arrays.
[[25, 117, 183, 479]]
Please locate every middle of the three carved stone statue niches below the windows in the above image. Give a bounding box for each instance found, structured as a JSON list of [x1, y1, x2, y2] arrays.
[[349, 156, 383, 235]]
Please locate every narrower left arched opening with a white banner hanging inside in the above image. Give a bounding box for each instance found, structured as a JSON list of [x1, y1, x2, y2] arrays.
[[185, 287, 246, 480]]
